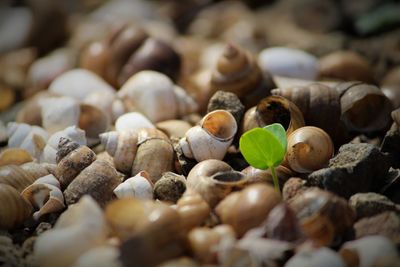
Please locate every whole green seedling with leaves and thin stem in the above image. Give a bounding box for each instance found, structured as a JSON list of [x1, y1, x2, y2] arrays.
[[239, 123, 287, 192]]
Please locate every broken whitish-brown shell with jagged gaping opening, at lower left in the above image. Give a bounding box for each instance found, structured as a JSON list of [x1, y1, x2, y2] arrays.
[[21, 174, 65, 220]]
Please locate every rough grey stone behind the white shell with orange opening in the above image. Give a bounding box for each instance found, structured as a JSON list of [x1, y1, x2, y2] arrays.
[[207, 91, 245, 125]]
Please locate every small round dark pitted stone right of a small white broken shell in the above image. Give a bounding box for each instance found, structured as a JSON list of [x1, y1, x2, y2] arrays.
[[154, 172, 186, 203]]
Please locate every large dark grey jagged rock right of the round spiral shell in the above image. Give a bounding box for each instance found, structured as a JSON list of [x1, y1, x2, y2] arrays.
[[306, 143, 390, 199]]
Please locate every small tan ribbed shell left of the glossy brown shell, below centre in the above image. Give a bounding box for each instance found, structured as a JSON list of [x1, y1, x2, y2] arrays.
[[176, 188, 211, 231]]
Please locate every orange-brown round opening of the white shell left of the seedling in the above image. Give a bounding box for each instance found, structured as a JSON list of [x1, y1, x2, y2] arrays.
[[201, 110, 237, 140]]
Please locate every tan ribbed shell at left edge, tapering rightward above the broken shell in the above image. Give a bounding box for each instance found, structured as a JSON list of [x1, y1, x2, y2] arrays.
[[0, 162, 55, 192]]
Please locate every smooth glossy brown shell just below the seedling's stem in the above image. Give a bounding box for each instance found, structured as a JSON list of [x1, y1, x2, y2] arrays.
[[215, 184, 281, 237]]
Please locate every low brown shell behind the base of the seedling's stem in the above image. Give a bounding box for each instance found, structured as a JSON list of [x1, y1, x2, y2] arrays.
[[242, 165, 294, 188]]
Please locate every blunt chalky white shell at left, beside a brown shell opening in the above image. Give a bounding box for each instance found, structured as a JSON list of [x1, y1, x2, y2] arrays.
[[40, 97, 81, 133]]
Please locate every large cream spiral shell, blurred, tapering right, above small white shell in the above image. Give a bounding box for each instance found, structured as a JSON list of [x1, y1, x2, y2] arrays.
[[117, 71, 197, 122]]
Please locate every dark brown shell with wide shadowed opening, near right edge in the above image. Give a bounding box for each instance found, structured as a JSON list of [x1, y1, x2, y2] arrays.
[[336, 82, 393, 133]]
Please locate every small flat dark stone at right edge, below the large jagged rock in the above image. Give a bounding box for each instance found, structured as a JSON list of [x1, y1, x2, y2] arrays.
[[349, 193, 397, 219]]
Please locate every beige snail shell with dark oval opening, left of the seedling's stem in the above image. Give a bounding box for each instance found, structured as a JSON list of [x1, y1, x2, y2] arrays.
[[186, 159, 247, 208]]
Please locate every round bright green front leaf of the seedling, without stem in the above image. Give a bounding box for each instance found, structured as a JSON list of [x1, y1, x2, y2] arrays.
[[239, 128, 285, 170]]
